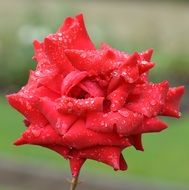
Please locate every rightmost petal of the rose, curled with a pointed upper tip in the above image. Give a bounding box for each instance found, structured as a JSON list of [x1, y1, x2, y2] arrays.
[[161, 86, 184, 118]]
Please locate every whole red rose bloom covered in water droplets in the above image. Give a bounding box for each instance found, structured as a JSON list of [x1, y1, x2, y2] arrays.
[[8, 15, 184, 176]]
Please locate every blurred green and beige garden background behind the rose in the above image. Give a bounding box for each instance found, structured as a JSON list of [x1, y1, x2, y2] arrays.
[[0, 0, 189, 190]]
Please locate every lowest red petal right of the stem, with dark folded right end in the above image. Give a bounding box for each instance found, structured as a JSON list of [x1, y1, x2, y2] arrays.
[[78, 146, 127, 170]]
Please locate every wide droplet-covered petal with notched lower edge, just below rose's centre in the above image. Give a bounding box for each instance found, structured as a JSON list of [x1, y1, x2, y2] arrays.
[[86, 109, 143, 136]]
